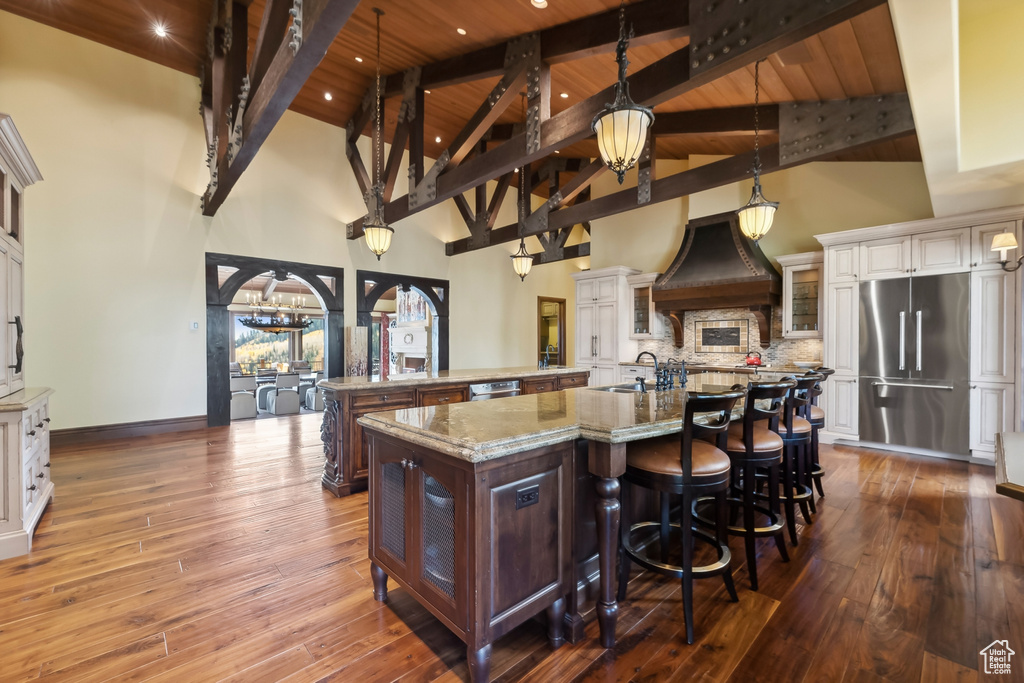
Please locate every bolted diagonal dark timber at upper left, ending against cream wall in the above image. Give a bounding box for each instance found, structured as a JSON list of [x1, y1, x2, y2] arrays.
[[203, 0, 358, 216]]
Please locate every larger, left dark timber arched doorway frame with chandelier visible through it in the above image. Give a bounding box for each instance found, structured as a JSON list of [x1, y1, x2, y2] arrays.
[[206, 253, 345, 427]]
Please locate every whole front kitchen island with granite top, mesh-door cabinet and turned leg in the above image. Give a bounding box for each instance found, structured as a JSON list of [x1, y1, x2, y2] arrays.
[[358, 373, 798, 681]]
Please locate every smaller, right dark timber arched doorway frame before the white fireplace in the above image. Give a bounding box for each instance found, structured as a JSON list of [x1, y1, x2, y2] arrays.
[[355, 270, 449, 373]]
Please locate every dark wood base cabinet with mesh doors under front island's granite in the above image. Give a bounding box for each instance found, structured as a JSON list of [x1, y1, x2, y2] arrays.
[[366, 429, 573, 681]]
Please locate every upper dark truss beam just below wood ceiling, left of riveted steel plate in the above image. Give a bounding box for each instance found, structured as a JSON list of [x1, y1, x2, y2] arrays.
[[385, 0, 689, 96]]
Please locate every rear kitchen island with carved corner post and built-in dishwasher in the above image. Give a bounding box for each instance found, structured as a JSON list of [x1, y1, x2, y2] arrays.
[[318, 366, 589, 497]]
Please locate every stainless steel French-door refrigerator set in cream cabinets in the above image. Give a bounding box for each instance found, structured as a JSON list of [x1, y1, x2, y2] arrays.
[[859, 272, 971, 456]]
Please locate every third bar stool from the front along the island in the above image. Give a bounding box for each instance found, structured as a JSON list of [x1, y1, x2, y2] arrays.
[[778, 373, 821, 546]]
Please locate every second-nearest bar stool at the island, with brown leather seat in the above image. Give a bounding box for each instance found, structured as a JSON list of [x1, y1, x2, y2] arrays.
[[697, 378, 797, 591]]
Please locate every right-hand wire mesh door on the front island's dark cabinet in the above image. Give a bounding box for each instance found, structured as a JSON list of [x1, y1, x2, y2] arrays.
[[413, 458, 470, 628]]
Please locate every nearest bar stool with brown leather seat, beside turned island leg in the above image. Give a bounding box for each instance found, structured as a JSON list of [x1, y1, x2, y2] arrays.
[[618, 390, 744, 644]]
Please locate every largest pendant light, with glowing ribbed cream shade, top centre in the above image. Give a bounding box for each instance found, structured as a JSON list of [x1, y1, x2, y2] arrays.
[[590, 4, 654, 184]]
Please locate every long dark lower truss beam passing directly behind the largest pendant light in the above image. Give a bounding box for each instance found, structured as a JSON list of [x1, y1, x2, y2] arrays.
[[348, 0, 885, 240]]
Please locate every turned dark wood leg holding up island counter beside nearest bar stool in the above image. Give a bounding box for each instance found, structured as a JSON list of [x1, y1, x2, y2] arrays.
[[589, 441, 626, 647]]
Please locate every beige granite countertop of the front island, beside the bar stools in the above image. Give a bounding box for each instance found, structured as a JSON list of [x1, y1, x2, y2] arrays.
[[358, 373, 774, 463]]
